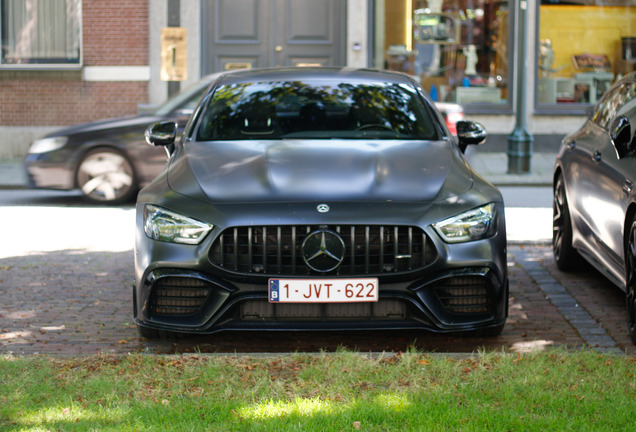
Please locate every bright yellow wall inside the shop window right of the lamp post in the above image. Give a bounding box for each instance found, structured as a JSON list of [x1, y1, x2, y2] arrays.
[[539, 6, 636, 77]]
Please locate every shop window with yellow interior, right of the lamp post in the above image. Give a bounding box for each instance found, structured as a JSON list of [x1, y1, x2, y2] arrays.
[[536, 0, 636, 111]]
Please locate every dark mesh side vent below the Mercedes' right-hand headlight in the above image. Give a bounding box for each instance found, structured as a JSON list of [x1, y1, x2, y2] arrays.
[[434, 276, 490, 314]]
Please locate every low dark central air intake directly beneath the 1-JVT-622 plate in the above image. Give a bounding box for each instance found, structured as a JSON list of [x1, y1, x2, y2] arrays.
[[241, 300, 407, 321]]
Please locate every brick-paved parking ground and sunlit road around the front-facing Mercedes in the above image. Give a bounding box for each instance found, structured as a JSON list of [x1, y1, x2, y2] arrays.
[[0, 188, 635, 355]]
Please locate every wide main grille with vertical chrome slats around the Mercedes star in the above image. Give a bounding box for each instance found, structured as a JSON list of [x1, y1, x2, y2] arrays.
[[210, 225, 437, 276]]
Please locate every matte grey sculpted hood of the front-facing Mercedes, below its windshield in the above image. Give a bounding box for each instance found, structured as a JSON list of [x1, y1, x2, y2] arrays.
[[168, 140, 473, 203]]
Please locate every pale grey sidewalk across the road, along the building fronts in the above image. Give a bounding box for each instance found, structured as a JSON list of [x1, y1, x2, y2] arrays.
[[0, 149, 556, 189]]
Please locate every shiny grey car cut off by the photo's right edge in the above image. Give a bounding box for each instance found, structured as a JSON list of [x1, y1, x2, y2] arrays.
[[552, 73, 636, 343]]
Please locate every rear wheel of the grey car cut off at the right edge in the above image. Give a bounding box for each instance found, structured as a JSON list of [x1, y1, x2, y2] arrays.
[[552, 176, 580, 271]]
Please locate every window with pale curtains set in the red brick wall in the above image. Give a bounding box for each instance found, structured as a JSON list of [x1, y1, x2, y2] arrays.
[[0, 0, 81, 67]]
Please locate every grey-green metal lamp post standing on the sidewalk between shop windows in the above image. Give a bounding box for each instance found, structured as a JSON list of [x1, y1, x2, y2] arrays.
[[508, 0, 533, 174]]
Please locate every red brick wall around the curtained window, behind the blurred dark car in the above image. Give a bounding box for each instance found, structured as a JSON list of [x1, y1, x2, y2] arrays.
[[0, 0, 149, 126]]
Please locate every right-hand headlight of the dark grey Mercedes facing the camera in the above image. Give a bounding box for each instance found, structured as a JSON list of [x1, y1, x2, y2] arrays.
[[433, 203, 497, 243]]
